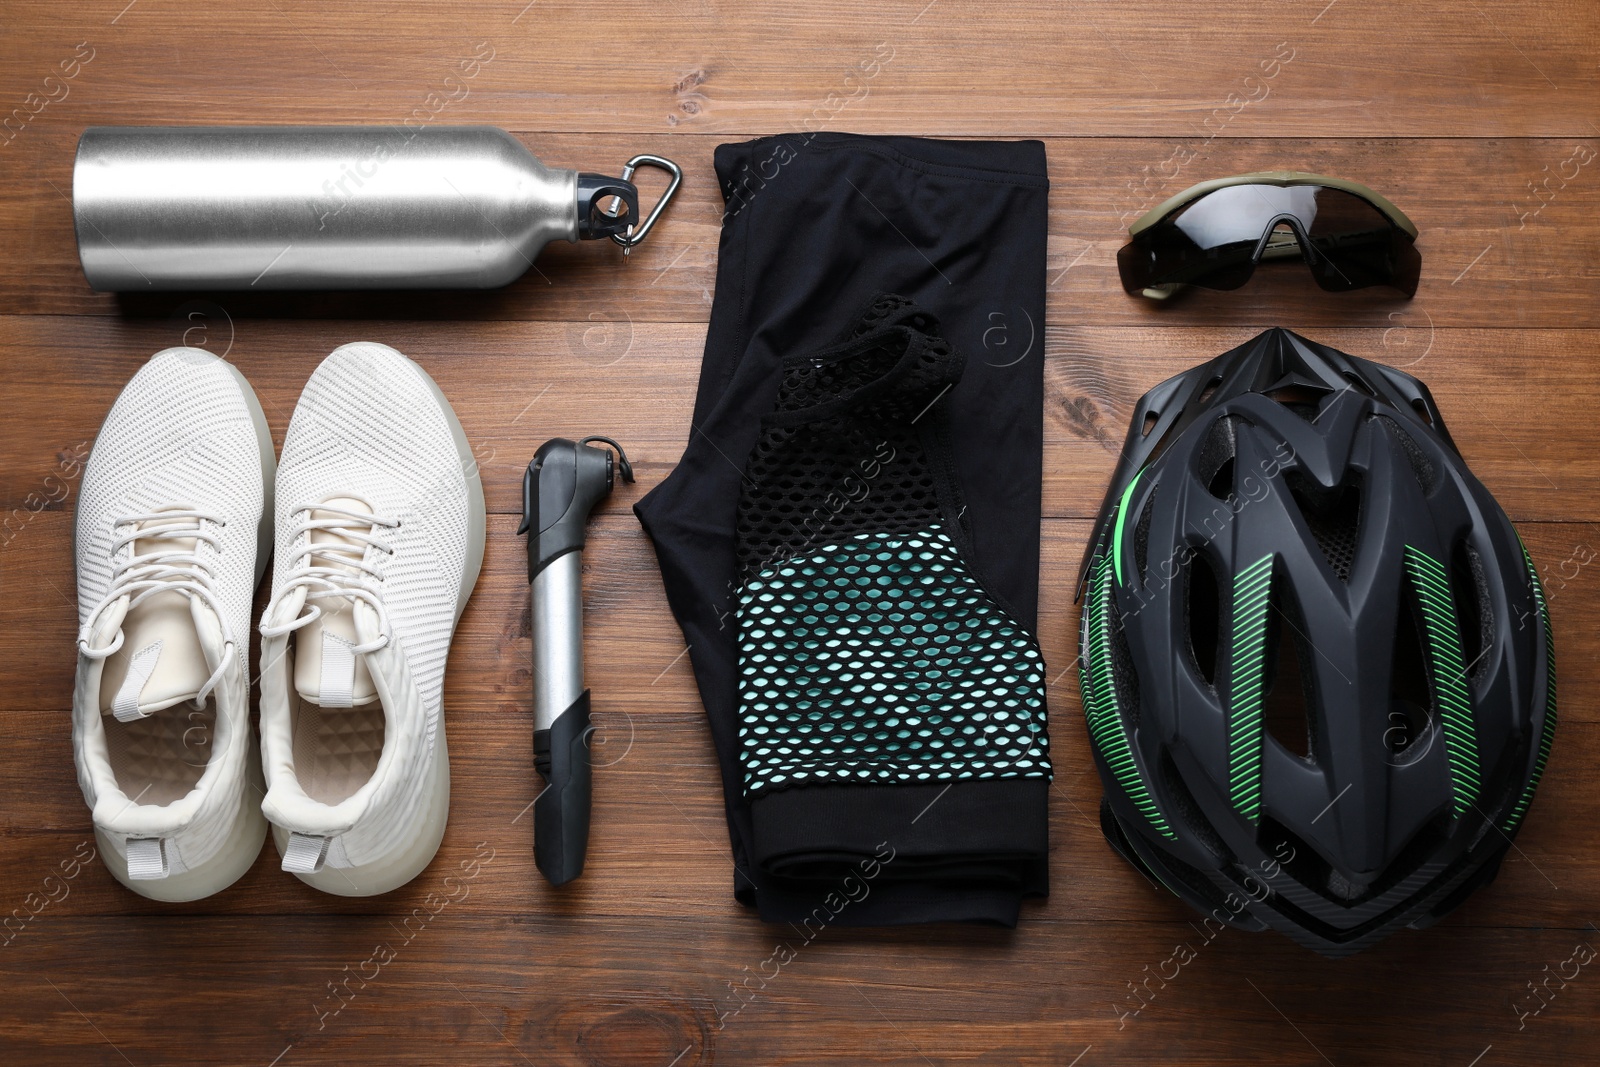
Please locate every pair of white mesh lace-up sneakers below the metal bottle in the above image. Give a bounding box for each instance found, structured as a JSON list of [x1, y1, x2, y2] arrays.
[[72, 344, 485, 901]]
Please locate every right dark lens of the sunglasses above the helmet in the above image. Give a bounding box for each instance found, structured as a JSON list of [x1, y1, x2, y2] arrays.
[[1306, 189, 1422, 296]]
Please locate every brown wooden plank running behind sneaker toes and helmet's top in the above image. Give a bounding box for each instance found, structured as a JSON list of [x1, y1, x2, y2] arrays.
[[0, 316, 1600, 521]]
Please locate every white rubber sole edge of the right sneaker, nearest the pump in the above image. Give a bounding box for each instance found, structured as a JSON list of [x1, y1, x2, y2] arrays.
[[272, 346, 488, 896]]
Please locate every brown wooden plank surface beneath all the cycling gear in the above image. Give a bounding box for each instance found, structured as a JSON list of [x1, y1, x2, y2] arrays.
[[0, 0, 1600, 1067]]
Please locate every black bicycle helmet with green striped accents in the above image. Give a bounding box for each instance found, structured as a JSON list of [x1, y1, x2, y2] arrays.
[[1078, 330, 1555, 955]]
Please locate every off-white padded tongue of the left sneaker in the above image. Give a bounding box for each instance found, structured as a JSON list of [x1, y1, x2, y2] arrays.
[[101, 524, 222, 723]]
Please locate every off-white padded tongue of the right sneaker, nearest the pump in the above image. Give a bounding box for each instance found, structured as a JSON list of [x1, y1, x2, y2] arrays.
[[294, 498, 378, 707]]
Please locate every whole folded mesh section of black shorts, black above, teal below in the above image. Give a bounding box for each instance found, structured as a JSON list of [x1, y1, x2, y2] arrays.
[[738, 296, 1050, 795]]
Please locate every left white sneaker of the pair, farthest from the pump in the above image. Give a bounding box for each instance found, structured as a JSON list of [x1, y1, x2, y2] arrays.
[[72, 349, 274, 901]]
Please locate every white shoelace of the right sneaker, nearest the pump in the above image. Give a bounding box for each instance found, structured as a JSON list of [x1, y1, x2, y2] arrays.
[[261, 498, 400, 653]]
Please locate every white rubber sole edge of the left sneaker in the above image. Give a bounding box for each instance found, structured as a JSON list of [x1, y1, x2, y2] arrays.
[[93, 349, 278, 904]]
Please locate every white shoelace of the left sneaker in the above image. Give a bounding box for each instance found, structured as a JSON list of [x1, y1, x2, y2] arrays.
[[78, 506, 237, 707]]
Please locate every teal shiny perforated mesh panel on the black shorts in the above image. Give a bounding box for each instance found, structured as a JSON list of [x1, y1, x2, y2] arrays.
[[739, 528, 1050, 793]]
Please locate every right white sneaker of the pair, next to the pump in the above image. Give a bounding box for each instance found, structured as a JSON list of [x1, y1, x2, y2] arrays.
[[252, 344, 483, 896]]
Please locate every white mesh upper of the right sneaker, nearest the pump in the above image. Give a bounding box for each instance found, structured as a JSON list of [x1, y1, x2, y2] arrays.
[[261, 344, 482, 867]]
